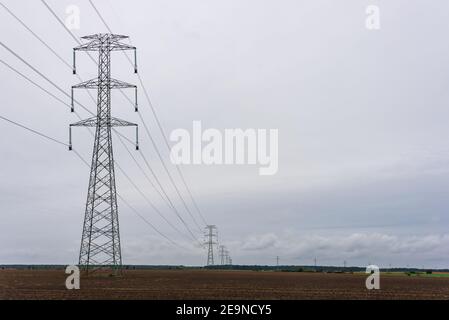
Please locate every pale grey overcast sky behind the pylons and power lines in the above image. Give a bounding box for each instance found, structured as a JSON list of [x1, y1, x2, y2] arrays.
[[0, 0, 449, 268]]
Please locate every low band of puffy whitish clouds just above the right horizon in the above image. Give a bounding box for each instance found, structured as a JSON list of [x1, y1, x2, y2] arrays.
[[232, 232, 449, 267]]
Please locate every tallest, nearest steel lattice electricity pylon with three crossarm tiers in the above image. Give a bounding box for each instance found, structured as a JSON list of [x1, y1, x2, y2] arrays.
[[69, 34, 139, 273]]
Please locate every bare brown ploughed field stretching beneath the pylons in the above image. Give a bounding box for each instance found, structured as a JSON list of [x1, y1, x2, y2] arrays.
[[0, 270, 449, 300]]
